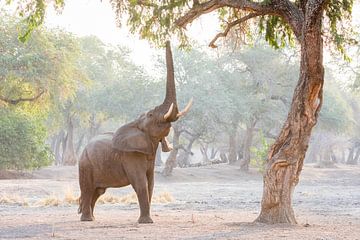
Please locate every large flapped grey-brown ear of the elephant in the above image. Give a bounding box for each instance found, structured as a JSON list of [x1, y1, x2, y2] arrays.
[[112, 125, 154, 154]]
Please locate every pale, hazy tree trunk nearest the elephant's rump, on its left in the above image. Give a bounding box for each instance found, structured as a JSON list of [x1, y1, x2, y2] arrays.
[[62, 117, 77, 166]]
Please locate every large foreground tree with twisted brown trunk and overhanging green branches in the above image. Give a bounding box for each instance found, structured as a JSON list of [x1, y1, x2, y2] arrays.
[[7, 0, 353, 223]]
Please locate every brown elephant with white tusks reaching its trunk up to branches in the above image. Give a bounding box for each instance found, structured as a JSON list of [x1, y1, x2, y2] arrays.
[[78, 41, 192, 223]]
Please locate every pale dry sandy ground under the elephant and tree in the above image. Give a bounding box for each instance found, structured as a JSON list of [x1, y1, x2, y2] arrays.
[[0, 165, 360, 240]]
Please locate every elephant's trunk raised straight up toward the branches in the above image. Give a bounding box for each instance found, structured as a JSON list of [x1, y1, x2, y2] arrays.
[[161, 41, 179, 122]]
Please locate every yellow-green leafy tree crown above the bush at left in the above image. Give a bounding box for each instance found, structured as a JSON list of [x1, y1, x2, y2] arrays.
[[0, 14, 82, 111]]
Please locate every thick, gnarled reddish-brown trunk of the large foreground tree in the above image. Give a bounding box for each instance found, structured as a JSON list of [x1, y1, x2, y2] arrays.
[[256, 14, 324, 224]]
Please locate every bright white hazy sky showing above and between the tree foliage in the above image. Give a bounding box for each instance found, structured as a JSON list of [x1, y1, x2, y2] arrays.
[[45, 0, 218, 67]]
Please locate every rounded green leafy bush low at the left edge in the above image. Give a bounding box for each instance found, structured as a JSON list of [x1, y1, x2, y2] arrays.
[[0, 109, 53, 170]]
